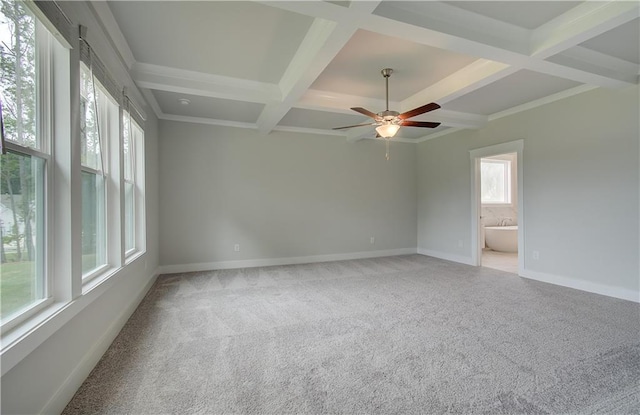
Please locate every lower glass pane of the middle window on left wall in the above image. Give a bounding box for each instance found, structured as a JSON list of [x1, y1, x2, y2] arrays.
[[82, 171, 107, 275]]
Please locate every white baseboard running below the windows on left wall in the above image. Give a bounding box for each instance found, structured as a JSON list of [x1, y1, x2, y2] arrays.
[[39, 268, 159, 414]]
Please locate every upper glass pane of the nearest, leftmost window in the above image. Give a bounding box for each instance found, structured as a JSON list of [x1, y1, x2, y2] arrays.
[[0, 1, 39, 148]]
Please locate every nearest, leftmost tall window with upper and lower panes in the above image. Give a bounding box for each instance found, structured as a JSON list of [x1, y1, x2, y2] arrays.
[[0, 2, 51, 327]]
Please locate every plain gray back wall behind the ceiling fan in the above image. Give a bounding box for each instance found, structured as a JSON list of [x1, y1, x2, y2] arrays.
[[160, 121, 417, 265]]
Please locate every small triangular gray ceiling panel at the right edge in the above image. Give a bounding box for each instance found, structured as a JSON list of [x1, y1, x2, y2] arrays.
[[581, 18, 640, 64]]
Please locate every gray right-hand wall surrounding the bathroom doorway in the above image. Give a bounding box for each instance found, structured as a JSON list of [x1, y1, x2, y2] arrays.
[[418, 87, 640, 293]]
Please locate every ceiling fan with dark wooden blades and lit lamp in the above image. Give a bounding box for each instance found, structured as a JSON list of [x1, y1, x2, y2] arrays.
[[334, 68, 440, 139]]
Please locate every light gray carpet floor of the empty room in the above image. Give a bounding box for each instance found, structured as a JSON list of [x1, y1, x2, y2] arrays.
[[64, 255, 640, 414]]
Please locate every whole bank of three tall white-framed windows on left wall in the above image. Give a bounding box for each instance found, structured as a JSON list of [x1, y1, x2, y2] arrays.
[[0, 0, 145, 342]]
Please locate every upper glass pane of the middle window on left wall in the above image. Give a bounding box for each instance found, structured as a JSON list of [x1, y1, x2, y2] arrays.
[[80, 64, 104, 170]]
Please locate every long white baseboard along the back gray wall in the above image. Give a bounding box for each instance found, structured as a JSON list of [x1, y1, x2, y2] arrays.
[[160, 248, 417, 274]]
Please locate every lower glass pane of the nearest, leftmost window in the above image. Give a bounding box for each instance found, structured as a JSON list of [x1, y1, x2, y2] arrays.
[[0, 152, 46, 320]]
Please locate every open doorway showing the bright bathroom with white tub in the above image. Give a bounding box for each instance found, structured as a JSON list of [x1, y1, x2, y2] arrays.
[[470, 140, 525, 275]]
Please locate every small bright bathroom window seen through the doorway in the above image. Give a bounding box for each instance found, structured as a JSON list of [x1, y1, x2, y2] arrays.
[[480, 158, 511, 204]]
